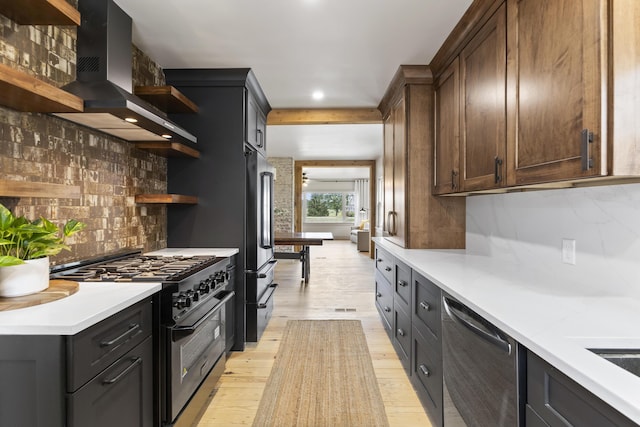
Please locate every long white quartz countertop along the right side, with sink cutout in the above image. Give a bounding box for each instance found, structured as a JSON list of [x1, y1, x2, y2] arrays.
[[374, 238, 640, 424]]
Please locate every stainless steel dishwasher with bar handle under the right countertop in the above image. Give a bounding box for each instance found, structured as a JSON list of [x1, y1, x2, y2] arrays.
[[442, 292, 524, 427]]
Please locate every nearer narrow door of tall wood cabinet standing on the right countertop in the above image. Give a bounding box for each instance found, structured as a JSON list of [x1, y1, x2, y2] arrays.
[[390, 95, 409, 246]]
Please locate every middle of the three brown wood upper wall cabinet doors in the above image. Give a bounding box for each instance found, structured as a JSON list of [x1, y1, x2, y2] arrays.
[[460, 4, 507, 191]]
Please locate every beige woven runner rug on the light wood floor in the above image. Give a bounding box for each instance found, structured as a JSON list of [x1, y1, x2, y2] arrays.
[[253, 320, 389, 427]]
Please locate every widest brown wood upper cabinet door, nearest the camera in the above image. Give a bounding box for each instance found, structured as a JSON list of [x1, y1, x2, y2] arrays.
[[507, 0, 606, 185]]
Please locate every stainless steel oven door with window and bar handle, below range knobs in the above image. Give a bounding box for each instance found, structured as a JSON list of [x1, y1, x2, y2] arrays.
[[163, 291, 234, 422]]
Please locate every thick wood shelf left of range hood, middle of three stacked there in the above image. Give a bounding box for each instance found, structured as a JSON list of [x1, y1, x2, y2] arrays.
[[0, 62, 84, 113]]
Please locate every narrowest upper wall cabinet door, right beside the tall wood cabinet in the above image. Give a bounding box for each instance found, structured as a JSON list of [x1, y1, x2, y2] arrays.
[[433, 58, 460, 194]]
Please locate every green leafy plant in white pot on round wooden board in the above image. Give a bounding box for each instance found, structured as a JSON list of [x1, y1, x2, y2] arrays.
[[0, 204, 86, 297]]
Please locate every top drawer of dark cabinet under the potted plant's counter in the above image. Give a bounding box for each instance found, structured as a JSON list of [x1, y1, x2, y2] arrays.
[[67, 298, 152, 392]]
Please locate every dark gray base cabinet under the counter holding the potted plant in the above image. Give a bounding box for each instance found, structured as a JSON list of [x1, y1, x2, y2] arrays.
[[0, 298, 157, 427]]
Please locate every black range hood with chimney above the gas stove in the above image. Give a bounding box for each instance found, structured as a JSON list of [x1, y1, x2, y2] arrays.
[[55, 0, 197, 148]]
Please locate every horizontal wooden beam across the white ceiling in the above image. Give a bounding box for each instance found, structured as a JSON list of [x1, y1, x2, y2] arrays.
[[267, 108, 382, 125]]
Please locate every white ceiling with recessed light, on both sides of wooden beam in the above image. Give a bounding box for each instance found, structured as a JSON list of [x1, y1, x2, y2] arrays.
[[112, 0, 471, 177]]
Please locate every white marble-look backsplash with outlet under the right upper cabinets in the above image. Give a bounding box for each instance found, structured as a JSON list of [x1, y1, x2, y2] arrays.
[[467, 184, 640, 295]]
